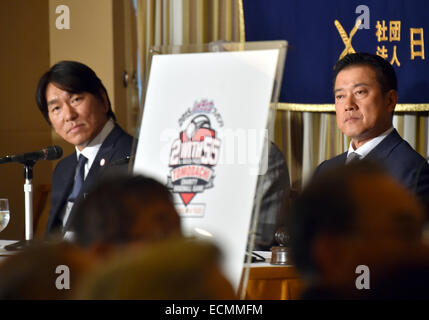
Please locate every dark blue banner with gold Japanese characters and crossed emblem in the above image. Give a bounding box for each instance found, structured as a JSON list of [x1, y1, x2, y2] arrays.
[[243, 0, 429, 104]]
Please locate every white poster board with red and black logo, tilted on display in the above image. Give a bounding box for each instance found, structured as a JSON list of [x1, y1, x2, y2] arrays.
[[132, 41, 286, 289]]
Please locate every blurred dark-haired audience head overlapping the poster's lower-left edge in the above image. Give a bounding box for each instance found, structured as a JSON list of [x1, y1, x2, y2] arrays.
[[70, 175, 181, 247]]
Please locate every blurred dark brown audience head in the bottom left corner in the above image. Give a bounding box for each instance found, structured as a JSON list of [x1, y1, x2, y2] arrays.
[[0, 243, 95, 300]]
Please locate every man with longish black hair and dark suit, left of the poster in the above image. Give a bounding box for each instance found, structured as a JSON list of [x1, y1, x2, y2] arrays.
[[36, 61, 133, 235]]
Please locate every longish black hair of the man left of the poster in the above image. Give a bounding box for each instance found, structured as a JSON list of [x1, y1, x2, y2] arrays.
[[36, 61, 116, 124]]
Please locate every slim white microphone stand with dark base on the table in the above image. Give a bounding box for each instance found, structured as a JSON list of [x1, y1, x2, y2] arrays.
[[4, 160, 36, 251]]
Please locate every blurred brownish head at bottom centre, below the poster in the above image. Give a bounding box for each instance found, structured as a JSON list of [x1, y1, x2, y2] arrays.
[[75, 239, 235, 300]]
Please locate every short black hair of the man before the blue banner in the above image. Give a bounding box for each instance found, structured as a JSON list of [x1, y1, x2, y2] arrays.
[[333, 52, 398, 94]]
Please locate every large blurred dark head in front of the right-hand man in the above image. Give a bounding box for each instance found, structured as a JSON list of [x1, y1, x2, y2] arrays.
[[288, 161, 424, 298]]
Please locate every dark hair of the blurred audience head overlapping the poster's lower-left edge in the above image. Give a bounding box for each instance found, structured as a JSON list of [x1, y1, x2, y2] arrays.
[[70, 174, 180, 247]]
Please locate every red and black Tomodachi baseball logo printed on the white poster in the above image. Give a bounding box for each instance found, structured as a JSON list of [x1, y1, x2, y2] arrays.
[[167, 99, 223, 216]]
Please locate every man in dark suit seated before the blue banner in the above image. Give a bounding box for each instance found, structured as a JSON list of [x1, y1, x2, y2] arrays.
[[315, 53, 429, 212]]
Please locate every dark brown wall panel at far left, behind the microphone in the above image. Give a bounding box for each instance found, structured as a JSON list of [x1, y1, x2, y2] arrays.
[[0, 0, 52, 239]]
